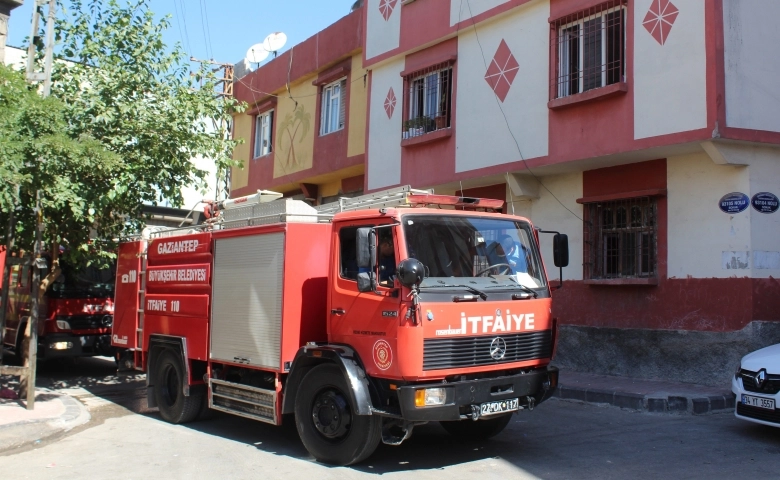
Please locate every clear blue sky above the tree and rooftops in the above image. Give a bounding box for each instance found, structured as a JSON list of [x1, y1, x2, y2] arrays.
[[7, 0, 354, 63]]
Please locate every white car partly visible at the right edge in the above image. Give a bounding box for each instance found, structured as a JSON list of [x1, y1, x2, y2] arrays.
[[731, 344, 780, 427]]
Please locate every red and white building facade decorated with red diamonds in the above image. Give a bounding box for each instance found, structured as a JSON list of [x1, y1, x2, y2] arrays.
[[233, 0, 780, 385]]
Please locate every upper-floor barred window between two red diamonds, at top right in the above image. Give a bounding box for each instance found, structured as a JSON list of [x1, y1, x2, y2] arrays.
[[553, 0, 626, 98]]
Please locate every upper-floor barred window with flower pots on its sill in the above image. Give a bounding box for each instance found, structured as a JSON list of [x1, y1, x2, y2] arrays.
[[403, 64, 452, 138]]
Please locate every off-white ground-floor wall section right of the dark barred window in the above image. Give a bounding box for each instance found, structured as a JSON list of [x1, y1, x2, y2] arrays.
[[666, 154, 754, 278]]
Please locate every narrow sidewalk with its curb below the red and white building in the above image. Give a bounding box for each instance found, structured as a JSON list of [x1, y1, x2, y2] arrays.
[[553, 371, 734, 415]]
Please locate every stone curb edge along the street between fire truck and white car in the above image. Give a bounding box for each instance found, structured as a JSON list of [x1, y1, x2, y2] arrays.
[[553, 385, 735, 415]]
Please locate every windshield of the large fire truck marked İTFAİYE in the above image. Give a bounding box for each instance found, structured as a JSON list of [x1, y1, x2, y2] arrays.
[[402, 214, 547, 289]]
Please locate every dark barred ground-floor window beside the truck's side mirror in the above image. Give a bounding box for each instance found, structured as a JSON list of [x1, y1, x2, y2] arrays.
[[585, 197, 658, 279]]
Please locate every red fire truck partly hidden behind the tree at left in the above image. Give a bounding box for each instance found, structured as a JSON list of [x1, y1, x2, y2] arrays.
[[0, 252, 116, 360]]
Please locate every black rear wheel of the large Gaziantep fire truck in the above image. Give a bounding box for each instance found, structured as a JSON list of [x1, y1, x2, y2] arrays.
[[154, 350, 203, 423]]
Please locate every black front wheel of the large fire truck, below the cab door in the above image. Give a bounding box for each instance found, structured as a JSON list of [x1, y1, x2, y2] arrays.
[[295, 364, 382, 465]]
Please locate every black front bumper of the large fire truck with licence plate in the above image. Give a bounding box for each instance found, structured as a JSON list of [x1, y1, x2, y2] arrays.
[[398, 366, 558, 422]]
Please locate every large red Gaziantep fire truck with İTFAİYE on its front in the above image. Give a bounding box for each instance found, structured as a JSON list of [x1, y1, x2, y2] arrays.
[[112, 187, 568, 465]]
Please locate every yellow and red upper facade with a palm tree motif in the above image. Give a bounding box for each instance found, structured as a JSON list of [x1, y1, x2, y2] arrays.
[[231, 8, 368, 203]]
